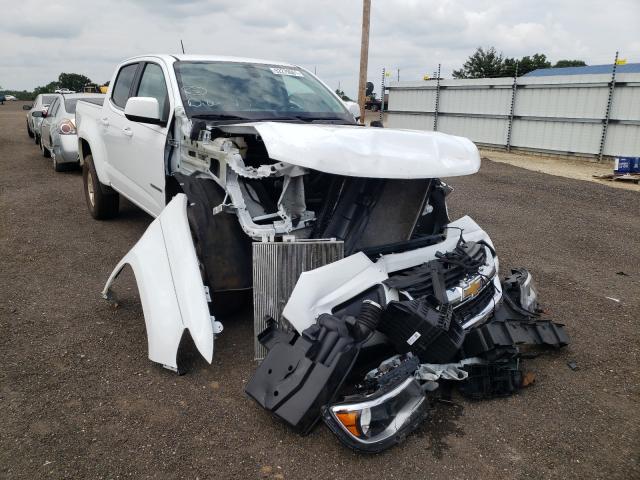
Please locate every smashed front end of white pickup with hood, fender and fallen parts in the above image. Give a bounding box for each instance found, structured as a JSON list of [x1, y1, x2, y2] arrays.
[[103, 111, 568, 452]]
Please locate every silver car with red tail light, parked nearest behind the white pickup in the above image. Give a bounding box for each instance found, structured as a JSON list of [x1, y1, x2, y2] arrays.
[[40, 93, 105, 172]]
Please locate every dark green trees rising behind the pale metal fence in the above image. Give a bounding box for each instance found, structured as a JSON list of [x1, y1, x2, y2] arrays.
[[453, 47, 587, 78]]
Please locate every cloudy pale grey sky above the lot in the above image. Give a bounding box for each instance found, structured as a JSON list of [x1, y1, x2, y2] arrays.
[[0, 0, 640, 97]]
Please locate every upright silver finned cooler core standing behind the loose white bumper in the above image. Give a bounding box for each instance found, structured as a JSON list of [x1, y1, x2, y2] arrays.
[[253, 240, 344, 360]]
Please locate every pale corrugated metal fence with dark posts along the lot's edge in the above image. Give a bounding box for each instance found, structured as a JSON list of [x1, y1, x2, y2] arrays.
[[387, 73, 640, 156]]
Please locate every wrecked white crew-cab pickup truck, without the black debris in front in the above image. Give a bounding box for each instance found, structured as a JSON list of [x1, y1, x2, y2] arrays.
[[76, 55, 524, 378]]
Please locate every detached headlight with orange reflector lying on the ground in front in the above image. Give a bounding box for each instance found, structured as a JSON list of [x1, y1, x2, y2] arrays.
[[323, 377, 428, 453]]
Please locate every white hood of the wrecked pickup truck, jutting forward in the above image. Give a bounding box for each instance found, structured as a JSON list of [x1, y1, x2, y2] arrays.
[[251, 122, 480, 178]]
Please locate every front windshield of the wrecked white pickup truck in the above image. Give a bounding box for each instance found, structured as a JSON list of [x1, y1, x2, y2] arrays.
[[174, 62, 354, 123]]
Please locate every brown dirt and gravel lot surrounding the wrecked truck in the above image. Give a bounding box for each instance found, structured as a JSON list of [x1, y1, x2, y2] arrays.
[[0, 99, 640, 480]]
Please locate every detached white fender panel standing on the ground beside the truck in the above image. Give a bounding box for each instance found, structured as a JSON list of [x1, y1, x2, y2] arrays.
[[102, 194, 216, 369]]
